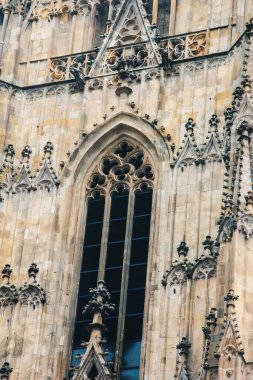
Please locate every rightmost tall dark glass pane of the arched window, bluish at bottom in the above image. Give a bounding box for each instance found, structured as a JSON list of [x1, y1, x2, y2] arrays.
[[121, 189, 152, 372]]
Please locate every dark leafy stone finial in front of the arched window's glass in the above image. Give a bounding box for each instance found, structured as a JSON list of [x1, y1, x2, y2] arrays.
[[83, 280, 114, 316]]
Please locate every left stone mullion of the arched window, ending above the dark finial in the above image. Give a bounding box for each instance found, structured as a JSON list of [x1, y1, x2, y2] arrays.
[[98, 192, 112, 281]]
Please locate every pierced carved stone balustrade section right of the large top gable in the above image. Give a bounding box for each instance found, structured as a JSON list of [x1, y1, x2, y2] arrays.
[[163, 33, 206, 61]]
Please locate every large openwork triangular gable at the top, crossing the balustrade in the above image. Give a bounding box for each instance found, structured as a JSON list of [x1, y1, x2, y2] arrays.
[[89, 0, 159, 77]]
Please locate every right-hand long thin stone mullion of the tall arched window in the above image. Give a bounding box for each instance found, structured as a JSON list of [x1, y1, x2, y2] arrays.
[[114, 192, 135, 379]]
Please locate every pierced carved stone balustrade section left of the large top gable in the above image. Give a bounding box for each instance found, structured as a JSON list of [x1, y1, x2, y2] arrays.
[[50, 50, 97, 81]]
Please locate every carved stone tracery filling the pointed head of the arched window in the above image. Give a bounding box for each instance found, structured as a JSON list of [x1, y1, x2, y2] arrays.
[[87, 141, 154, 196]]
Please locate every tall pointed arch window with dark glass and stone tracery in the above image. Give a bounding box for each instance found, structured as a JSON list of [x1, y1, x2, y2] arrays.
[[72, 141, 154, 380]]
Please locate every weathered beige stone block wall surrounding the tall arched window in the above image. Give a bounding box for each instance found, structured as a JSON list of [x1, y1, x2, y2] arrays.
[[0, 0, 253, 380]]
